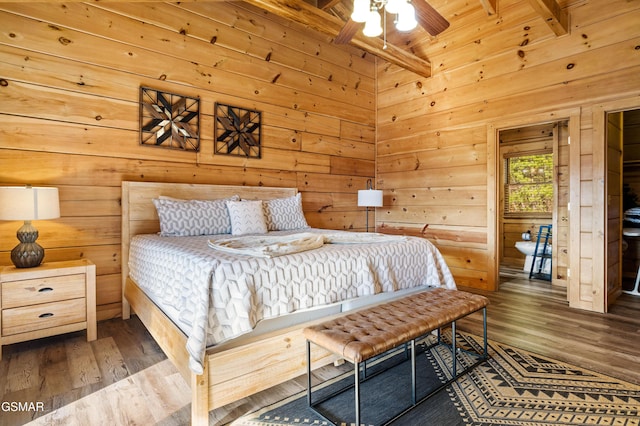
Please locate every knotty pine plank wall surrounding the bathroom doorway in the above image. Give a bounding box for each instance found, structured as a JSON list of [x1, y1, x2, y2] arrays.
[[377, 0, 640, 311]]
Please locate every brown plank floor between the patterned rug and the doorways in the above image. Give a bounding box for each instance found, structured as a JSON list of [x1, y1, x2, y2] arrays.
[[458, 271, 640, 384]]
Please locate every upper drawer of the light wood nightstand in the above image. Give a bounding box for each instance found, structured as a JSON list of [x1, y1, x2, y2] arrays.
[[2, 274, 86, 309]]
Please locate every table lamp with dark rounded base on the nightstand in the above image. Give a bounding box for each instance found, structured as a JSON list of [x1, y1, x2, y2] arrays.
[[0, 185, 60, 268]]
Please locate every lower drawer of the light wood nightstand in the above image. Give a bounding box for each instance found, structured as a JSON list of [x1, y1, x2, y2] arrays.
[[2, 298, 87, 336]]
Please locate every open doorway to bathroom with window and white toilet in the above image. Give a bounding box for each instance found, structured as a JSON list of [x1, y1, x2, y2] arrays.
[[496, 120, 569, 287]]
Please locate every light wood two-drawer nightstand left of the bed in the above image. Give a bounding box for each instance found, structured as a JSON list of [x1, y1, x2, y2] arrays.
[[0, 259, 97, 359]]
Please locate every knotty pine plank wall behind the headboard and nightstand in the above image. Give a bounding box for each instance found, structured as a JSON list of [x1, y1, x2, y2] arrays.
[[0, 2, 376, 319]]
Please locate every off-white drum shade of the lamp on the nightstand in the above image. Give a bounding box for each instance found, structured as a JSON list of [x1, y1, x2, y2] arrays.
[[0, 186, 60, 220]]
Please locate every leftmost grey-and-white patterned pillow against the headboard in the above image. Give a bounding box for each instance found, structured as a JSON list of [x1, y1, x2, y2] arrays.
[[153, 195, 240, 237]]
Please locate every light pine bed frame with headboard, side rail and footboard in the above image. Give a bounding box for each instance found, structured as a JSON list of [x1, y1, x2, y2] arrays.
[[122, 182, 336, 425]]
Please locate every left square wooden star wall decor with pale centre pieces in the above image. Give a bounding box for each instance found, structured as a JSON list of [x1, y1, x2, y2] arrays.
[[140, 87, 200, 152]]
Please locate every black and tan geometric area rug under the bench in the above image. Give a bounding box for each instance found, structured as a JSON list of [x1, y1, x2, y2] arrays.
[[233, 334, 640, 426]]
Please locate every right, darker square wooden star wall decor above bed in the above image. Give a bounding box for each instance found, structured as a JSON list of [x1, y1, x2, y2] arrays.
[[214, 102, 262, 158]]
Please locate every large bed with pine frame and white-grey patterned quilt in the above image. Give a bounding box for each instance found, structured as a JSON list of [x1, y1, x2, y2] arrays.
[[122, 182, 455, 424]]
